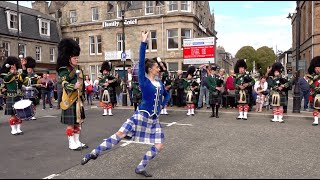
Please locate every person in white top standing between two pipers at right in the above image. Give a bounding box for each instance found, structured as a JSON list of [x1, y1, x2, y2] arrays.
[[253, 76, 268, 112]]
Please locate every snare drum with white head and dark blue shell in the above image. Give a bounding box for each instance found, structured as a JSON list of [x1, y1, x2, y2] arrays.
[[13, 99, 35, 120]]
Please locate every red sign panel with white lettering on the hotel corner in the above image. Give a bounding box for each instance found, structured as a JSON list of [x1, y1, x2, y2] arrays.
[[183, 45, 214, 59]]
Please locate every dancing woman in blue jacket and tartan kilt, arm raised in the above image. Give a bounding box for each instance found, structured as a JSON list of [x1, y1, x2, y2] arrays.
[[81, 32, 169, 177]]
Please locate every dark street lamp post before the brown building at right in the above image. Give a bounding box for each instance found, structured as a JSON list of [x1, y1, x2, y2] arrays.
[[287, 1, 301, 113]]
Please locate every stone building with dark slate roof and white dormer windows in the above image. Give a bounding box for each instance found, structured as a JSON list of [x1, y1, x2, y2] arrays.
[[0, 1, 60, 74]]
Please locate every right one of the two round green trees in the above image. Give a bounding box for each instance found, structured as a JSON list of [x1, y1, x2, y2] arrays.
[[256, 46, 276, 74]]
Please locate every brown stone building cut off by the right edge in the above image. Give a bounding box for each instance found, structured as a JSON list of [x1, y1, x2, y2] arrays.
[[288, 1, 320, 74]]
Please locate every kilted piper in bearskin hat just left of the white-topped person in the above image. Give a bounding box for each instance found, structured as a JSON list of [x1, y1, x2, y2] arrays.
[[234, 59, 254, 120]]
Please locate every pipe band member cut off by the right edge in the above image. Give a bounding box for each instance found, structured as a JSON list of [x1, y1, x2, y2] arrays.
[[307, 56, 320, 126]]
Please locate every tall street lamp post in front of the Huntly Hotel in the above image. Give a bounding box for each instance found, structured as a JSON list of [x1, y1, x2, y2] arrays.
[[117, 1, 131, 106]]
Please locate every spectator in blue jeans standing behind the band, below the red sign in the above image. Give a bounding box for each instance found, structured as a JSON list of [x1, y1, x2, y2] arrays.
[[197, 64, 210, 109]]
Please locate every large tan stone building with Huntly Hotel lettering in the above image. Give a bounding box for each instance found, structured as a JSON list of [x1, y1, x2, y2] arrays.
[[49, 1, 216, 79]]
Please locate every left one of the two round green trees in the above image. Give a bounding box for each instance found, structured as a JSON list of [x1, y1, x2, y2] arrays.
[[236, 46, 257, 71]]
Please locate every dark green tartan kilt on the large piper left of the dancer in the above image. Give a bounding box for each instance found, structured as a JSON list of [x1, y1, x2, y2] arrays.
[[61, 102, 86, 125]]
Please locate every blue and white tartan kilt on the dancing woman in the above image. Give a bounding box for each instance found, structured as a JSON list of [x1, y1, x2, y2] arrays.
[[119, 110, 164, 144]]
